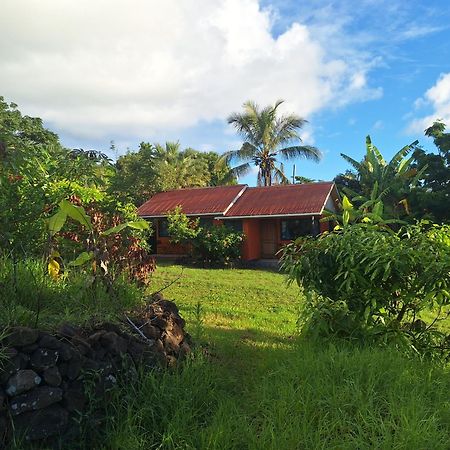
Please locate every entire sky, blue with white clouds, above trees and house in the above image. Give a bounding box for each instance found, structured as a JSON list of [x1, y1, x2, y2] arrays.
[[0, 0, 450, 184]]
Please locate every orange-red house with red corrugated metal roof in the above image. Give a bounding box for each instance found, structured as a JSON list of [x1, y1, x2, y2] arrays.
[[138, 182, 338, 261]]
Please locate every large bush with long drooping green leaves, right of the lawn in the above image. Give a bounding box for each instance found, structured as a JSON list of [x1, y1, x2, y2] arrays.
[[282, 224, 450, 354]]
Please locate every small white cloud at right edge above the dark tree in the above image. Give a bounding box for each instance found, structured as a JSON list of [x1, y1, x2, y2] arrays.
[[409, 72, 450, 133]]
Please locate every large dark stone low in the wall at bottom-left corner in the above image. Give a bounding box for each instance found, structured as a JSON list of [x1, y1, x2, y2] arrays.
[[14, 405, 69, 441]]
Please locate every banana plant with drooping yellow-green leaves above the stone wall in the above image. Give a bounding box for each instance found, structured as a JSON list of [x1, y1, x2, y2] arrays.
[[47, 200, 150, 279]]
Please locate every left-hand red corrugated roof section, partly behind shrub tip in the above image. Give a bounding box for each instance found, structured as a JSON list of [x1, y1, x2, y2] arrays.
[[138, 184, 246, 217]]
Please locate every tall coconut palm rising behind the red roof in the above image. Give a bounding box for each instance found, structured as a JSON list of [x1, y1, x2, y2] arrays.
[[221, 100, 322, 186]]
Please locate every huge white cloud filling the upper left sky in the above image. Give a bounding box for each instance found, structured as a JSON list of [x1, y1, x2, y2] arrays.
[[0, 0, 381, 138]]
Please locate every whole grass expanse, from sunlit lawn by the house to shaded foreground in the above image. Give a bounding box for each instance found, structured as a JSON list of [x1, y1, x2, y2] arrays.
[[97, 265, 450, 450]]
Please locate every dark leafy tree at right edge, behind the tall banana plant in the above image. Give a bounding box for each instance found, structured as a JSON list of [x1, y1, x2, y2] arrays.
[[411, 121, 450, 222]]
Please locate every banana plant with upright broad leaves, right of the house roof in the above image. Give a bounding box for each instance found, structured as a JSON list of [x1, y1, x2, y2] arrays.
[[336, 136, 425, 219]]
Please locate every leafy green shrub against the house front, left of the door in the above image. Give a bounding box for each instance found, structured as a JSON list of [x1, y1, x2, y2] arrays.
[[167, 208, 244, 264]]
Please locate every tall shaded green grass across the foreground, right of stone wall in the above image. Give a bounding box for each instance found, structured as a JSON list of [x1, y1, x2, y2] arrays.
[[92, 342, 450, 450]]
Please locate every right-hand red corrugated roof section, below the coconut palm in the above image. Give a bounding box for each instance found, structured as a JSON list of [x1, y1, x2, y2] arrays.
[[226, 182, 334, 217]]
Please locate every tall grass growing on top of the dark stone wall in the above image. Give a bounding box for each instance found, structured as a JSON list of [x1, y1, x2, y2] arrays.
[[0, 257, 142, 328]]
